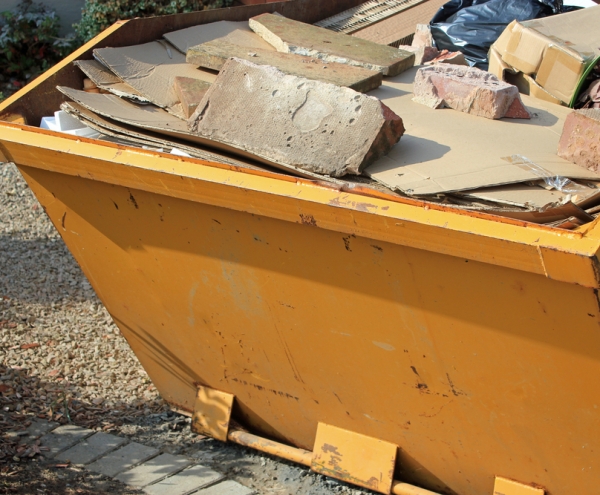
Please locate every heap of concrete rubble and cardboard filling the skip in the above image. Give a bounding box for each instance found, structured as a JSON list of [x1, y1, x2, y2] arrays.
[[42, 2, 600, 229]]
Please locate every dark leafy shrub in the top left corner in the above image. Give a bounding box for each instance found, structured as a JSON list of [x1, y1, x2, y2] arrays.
[[0, 0, 73, 81]]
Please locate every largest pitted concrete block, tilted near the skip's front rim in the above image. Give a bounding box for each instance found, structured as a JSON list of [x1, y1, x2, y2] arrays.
[[188, 58, 404, 177]]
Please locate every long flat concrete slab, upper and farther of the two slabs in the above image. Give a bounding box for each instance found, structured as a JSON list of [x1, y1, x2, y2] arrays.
[[249, 14, 414, 76]]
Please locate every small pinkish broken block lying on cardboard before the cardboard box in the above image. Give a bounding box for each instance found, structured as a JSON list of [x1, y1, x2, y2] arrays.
[[413, 64, 531, 119]]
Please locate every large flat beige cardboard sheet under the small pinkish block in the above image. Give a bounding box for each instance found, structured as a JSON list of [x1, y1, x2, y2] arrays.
[[365, 68, 599, 195]]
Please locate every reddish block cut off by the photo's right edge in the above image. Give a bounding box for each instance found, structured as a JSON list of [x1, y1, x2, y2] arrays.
[[558, 108, 600, 172]]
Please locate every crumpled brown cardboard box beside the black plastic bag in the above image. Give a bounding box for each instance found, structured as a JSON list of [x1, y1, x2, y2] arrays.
[[492, 6, 600, 105]]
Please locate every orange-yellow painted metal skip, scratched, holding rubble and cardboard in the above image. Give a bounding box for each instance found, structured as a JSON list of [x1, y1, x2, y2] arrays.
[[0, 2, 600, 495]]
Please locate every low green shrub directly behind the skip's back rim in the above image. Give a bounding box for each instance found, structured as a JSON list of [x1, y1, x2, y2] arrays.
[[73, 0, 233, 41]]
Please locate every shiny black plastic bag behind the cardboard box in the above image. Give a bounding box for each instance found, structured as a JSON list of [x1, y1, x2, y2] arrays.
[[430, 0, 563, 70]]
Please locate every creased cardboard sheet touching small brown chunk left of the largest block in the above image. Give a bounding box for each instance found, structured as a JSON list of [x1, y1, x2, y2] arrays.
[[94, 41, 216, 118]]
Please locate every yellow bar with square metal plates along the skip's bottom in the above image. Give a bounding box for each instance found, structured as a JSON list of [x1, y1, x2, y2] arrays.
[[192, 386, 544, 495]]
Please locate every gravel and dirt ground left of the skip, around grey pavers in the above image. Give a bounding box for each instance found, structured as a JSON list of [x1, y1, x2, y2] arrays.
[[0, 163, 372, 495]]
